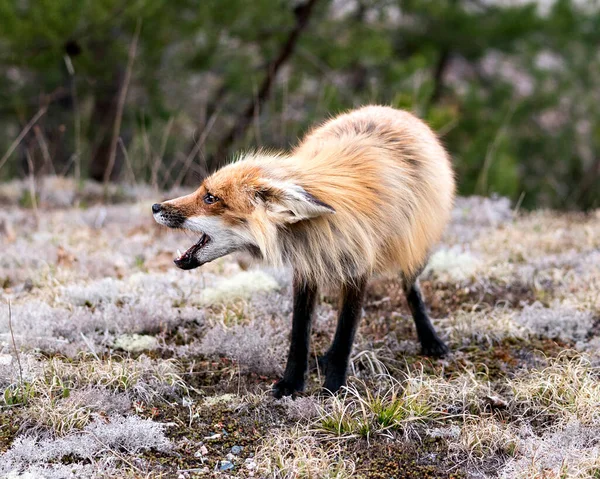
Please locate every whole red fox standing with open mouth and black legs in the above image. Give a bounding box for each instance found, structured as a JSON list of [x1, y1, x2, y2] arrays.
[[152, 106, 455, 397]]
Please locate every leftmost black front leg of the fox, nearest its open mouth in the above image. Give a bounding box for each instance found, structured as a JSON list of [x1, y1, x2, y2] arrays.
[[273, 278, 317, 398]]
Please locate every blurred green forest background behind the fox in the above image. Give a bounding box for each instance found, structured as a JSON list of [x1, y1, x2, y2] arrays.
[[0, 0, 600, 209]]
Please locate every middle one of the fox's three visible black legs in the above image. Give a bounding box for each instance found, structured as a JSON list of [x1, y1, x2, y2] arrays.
[[321, 278, 367, 393]]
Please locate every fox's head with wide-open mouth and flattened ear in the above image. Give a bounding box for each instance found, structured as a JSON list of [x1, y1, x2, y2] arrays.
[[152, 160, 335, 269]]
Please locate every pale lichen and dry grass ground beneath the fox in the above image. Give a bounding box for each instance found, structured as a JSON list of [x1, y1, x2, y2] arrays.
[[0, 179, 600, 479]]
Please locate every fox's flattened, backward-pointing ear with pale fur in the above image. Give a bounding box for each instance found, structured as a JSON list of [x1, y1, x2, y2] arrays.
[[259, 181, 335, 223]]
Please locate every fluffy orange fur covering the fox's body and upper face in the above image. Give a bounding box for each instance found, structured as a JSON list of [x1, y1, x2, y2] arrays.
[[168, 106, 455, 285]]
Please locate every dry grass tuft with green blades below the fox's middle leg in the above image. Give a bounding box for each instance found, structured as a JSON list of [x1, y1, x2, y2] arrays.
[[312, 362, 490, 439]]
